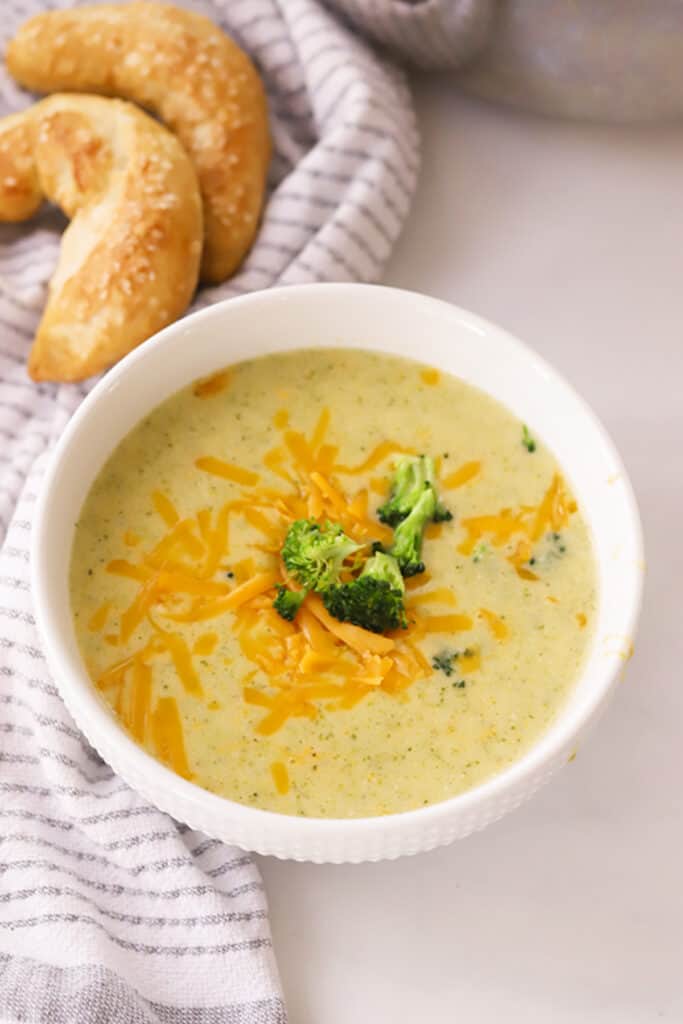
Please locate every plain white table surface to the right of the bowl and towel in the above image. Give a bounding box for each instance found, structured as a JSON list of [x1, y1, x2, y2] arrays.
[[255, 78, 683, 1024]]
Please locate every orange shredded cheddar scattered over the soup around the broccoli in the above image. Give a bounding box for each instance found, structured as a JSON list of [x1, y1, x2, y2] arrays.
[[93, 403, 548, 765]]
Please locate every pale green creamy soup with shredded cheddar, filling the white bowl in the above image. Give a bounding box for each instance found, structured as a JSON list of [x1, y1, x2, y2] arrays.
[[71, 349, 596, 817]]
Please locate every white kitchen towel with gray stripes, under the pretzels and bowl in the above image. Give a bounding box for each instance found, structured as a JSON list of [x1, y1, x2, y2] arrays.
[[0, 0, 418, 1024]]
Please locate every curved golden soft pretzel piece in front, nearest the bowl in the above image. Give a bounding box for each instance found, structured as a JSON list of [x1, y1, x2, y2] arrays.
[[0, 93, 202, 381]]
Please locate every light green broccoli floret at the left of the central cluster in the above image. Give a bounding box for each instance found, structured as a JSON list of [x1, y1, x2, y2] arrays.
[[282, 519, 362, 591]]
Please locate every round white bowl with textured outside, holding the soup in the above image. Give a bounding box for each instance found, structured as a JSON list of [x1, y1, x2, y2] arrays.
[[33, 285, 643, 862]]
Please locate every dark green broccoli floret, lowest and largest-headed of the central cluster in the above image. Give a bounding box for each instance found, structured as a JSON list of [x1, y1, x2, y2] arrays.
[[323, 552, 408, 633]]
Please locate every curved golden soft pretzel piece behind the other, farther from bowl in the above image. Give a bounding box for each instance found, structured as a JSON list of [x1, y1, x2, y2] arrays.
[[6, 0, 270, 282]]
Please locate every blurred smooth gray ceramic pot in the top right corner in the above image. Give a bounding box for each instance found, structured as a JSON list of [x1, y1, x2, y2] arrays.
[[458, 0, 683, 121]]
